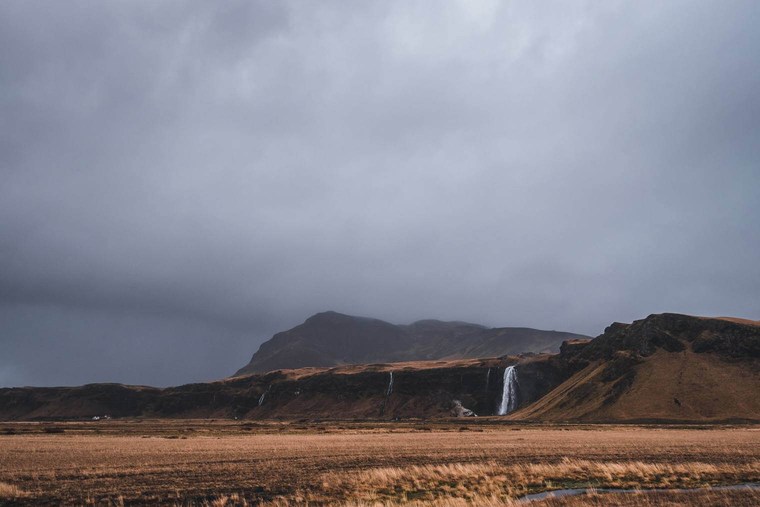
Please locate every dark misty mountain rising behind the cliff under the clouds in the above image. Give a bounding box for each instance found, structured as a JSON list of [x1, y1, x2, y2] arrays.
[[235, 312, 588, 376]]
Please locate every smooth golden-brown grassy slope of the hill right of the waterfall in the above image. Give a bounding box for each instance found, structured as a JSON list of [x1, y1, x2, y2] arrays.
[[508, 350, 760, 422]]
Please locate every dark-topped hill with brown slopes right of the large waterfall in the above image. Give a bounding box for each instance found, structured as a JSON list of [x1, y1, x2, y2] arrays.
[[509, 314, 760, 422]]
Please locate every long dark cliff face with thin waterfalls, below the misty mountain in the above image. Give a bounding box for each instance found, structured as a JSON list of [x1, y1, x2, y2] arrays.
[[0, 356, 562, 419]]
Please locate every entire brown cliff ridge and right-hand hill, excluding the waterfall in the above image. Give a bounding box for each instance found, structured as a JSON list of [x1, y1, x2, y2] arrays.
[[0, 314, 760, 423]]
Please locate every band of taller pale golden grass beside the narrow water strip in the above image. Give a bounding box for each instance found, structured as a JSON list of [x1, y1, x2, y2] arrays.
[[322, 458, 760, 501]]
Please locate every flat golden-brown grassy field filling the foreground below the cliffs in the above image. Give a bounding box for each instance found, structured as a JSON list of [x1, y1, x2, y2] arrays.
[[0, 419, 760, 506]]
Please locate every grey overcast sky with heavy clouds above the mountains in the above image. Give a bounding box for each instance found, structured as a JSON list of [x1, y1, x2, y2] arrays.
[[0, 0, 760, 386]]
